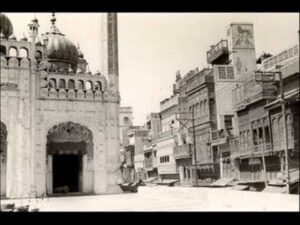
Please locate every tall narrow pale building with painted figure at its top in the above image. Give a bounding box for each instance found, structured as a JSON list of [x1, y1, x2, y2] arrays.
[[207, 23, 256, 178]]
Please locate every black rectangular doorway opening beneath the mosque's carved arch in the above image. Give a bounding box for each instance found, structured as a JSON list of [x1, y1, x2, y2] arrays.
[[53, 154, 82, 193]]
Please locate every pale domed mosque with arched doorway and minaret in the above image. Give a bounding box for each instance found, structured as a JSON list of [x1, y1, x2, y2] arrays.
[[0, 13, 121, 198]]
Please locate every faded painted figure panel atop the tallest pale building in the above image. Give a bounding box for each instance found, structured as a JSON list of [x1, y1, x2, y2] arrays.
[[232, 24, 254, 48]]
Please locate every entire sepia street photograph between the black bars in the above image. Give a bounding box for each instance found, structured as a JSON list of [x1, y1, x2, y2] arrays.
[[0, 12, 300, 213]]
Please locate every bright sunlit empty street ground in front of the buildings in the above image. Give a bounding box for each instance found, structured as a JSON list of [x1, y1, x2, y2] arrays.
[[1, 187, 299, 212]]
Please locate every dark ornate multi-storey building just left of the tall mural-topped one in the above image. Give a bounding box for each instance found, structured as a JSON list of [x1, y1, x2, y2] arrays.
[[174, 68, 219, 185]]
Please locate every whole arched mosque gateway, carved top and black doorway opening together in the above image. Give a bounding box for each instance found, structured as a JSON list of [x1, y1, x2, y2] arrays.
[[47, 122, 93, 194]]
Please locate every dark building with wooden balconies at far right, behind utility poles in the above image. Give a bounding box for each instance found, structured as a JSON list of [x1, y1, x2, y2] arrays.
[[232, 42, 299, 192]]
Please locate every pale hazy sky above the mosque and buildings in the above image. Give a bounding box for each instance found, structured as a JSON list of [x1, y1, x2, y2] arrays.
[[6, 13, 299, 125]]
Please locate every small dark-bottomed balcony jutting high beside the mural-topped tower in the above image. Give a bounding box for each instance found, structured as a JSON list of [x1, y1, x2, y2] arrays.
[[206, 40, 229, 64]]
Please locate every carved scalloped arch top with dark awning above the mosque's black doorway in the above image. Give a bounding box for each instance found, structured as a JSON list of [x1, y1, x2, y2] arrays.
[[47, 122, 93, 159]]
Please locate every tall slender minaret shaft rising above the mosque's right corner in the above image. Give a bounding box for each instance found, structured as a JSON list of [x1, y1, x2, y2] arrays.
[[102, 13, 119, 92]]
